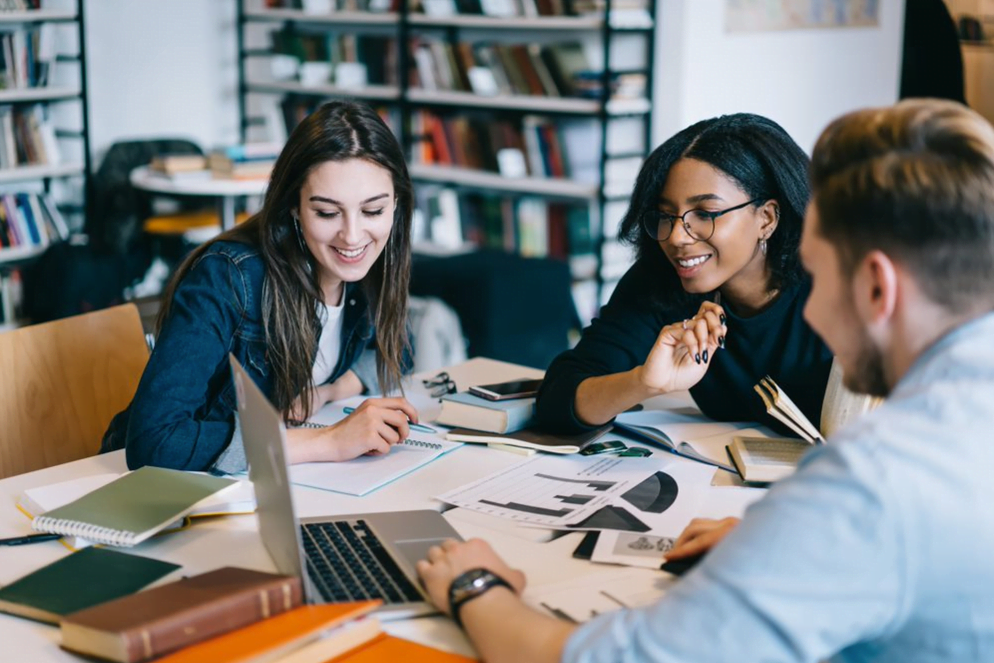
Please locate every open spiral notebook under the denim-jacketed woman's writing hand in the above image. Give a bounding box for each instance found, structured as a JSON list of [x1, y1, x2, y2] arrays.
[[290, 435, 462, 496]]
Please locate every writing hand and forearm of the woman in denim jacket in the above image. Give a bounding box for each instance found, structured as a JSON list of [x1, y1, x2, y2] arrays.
[[288, 398, 418, 463]]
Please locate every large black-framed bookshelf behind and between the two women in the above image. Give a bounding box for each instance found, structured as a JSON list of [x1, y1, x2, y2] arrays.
[[236, 0, 655, 320]]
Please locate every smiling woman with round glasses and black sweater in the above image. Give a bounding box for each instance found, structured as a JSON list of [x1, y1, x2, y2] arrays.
[[536, 113, 832, 432]]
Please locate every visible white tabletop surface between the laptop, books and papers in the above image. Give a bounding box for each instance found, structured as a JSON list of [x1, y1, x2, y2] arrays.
[[0, 359, 760, 663]]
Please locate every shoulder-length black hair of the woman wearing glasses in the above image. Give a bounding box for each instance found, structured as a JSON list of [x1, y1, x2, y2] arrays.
[[619, 113, 810, 305]]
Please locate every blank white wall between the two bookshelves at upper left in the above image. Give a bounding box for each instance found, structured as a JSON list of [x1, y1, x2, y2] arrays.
[[85, 0, 238, 168]]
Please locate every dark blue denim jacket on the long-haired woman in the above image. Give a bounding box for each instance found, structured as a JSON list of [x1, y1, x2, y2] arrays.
[[101, 241, 376, 473]]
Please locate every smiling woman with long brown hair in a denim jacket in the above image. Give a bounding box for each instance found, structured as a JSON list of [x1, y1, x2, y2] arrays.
[[102, 102, 418, 472]]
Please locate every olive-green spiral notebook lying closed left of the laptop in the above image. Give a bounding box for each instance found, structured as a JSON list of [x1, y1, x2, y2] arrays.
[[31, 467, 238, 546]]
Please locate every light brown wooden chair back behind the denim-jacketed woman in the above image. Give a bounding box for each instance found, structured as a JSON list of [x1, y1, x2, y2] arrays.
[[0, 304, 148, 478]]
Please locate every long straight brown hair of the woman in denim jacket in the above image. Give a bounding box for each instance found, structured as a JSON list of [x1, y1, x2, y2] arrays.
[[158, 101, 414, 418]]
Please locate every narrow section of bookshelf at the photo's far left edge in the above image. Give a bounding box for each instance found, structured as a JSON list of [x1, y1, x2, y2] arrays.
[[0, 0, 91, 331]]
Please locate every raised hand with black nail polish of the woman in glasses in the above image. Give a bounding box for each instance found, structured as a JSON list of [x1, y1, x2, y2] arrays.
[[639, 302, 728, 393]]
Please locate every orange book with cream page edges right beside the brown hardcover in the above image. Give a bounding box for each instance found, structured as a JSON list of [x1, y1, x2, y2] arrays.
[[157, 601, 383, 663]]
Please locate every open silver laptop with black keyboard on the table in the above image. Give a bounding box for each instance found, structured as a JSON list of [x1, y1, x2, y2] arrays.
[[229, 355, 461, 619]]
